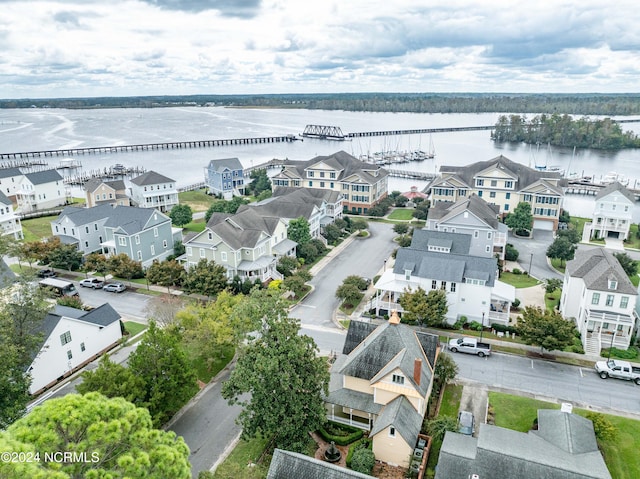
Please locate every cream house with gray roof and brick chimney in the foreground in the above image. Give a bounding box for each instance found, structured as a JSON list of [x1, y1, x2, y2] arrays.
[[325, 313, 439, 467]]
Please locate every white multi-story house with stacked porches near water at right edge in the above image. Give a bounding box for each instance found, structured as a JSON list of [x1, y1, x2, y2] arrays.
[[591, 181, 636, 240]]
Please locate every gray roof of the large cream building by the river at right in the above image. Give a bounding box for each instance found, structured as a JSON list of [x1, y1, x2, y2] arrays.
[[433, 155, 564, 191]]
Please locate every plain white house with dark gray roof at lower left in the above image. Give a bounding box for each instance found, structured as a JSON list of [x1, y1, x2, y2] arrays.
[[27, 303, 122, 394]]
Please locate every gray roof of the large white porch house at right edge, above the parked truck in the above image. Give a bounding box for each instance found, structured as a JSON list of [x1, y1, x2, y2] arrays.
[[566, 248, 638, 295]]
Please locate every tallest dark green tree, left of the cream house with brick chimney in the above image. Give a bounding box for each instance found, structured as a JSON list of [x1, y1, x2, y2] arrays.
[[222, 308, 329, 451]]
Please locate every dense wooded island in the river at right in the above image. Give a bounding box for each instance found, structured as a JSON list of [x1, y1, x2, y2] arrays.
[[491, 113, 640, 150]]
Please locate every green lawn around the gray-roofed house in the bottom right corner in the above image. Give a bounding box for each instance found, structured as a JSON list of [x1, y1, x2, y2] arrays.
[[489, 392, 640, 479]]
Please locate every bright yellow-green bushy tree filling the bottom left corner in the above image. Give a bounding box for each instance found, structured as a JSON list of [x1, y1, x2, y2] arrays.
[[0, 393, 191, 479]]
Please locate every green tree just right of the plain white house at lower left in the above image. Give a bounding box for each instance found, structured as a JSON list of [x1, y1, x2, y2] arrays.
[[129, 321, 198, 426]]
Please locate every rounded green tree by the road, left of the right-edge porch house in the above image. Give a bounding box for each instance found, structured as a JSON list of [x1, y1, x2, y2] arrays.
[[518, 306, 575, 351]]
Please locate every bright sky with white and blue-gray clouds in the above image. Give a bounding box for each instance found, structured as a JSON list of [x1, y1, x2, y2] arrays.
[[0, 0, 640, 98]]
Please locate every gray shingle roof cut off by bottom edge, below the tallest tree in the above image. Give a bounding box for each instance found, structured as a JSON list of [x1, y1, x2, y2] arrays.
[[267, 449, 371, 479]]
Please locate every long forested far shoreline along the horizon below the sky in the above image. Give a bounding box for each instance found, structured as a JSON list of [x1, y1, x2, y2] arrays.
[[0, 93, 640, 115]]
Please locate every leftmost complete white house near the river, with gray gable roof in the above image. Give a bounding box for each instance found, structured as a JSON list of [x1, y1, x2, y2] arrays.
[[15, 170, 67, 213]]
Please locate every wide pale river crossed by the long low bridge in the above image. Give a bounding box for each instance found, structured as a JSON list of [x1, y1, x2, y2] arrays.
[[0, 107, 640, 219]]
